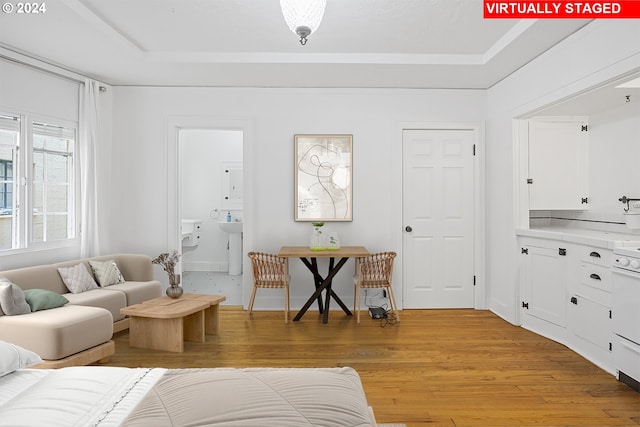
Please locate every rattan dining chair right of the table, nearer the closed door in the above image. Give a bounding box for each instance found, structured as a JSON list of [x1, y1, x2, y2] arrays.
[[353, 252, 400, 323]]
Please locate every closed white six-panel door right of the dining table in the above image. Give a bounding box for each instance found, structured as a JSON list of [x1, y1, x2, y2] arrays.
[[402, 129, 475, 308]]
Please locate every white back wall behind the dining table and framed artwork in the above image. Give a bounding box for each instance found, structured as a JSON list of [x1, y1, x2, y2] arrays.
[[109, 87, 486, 307]]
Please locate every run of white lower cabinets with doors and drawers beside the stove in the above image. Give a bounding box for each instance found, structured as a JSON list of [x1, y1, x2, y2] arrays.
[[519, 237, 616, 375]]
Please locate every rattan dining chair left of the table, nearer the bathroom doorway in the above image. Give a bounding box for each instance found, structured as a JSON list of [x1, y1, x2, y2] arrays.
[[248, 252, 290, 323]]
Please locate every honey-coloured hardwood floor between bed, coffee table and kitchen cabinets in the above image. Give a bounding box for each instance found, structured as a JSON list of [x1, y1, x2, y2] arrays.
[[106, 307, 640, 427]]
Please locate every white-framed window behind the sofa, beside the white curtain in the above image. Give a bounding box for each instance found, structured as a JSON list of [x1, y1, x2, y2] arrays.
[[0, 113, 76, 250]]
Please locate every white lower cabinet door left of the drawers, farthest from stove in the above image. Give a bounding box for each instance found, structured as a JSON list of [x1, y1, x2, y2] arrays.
[[520, 238, 567, 327]]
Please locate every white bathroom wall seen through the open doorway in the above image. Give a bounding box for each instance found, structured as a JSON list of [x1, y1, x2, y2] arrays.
[[180, 129, 243, 271]]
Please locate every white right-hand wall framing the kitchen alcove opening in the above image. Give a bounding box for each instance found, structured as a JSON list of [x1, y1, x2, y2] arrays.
[[486, 20, 640, 323]]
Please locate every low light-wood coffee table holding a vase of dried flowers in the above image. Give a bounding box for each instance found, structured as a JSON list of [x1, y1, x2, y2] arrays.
[[120, 294, 226, 352]]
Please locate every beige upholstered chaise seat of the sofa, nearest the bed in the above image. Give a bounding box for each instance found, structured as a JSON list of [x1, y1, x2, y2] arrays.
[[0, 304, 113, 360]]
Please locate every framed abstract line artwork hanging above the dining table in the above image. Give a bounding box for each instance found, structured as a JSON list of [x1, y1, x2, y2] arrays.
[[294, 134, 353, 222]]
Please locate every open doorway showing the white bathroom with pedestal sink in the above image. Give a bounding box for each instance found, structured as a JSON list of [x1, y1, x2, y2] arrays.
[[178, 128, 244, 305]]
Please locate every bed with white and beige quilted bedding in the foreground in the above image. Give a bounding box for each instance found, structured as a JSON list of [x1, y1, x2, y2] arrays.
[[0, 342, 375, 427]]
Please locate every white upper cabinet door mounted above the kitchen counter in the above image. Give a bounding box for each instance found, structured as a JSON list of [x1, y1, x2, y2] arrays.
[[527, 117, 588, 210]]
